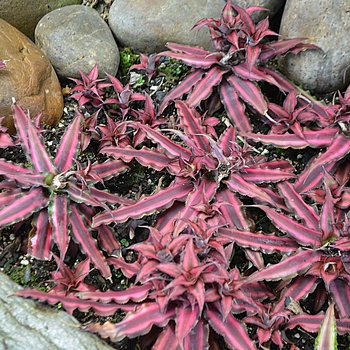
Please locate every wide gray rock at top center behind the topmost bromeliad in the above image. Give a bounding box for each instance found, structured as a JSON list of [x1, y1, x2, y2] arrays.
[[108, 0, 225, 54]]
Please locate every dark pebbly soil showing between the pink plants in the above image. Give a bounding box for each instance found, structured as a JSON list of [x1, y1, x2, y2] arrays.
[[0, 0, 348, 350]]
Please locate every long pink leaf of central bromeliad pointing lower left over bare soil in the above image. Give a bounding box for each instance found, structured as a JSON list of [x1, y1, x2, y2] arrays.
[[93, 181, 193, 227]]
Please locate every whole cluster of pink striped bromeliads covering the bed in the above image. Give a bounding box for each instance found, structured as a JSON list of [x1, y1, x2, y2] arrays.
[[0, 1, 350, 349]]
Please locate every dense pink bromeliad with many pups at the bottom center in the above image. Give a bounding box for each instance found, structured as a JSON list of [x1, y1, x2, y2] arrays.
[[19, 220, 273, 350]]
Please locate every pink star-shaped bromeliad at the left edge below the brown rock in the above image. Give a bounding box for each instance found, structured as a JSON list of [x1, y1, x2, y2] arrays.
[[0, 105, 133, 278]]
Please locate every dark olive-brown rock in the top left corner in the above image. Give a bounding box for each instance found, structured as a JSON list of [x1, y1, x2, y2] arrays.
[[0, 0, 82, 40]]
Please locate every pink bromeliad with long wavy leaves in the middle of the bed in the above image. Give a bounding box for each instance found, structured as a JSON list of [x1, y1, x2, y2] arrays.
[[93, 101, 295, 234]]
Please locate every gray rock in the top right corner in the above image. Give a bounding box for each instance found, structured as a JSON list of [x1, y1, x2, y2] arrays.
[[279, 0, 350, 93]]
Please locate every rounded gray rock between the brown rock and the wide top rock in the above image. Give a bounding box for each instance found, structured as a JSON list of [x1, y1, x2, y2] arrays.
[[35, 5, 120, 79]]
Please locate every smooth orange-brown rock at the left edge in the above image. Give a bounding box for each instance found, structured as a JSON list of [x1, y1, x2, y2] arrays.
[[0, 19, 63, 133]]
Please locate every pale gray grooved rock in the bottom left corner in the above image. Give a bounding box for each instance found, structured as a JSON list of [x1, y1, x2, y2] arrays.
[[0, 272, 113, 350]]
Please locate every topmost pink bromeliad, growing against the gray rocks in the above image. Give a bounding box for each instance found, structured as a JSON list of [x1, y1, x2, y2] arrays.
[[159, 0, 317, 132]]
